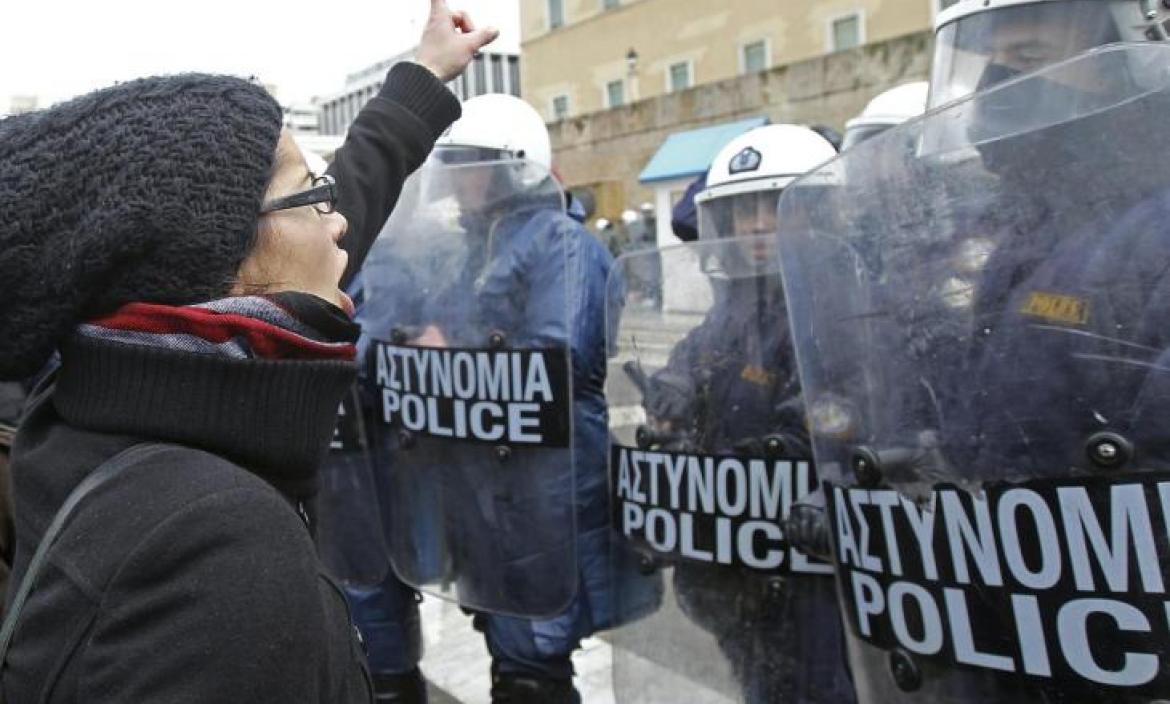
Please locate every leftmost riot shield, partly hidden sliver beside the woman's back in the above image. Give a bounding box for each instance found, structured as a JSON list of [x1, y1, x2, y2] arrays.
[[309, 387, 390, 586]]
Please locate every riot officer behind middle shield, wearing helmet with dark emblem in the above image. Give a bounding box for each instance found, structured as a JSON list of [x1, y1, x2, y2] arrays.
[[611, 125, 853, 703]]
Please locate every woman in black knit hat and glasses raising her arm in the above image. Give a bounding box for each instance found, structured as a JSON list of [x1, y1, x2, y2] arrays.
[[0, 0, 495, 704]]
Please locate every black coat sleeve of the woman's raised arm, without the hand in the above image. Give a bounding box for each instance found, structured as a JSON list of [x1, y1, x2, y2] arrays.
[[328, 62, 461, 288]]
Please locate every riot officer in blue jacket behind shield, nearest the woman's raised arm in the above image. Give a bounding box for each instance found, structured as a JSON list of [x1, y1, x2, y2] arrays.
[[359, 95, 612, 703]]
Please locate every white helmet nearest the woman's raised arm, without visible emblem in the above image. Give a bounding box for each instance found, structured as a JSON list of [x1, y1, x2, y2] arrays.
[[435, 94, 552, 171]]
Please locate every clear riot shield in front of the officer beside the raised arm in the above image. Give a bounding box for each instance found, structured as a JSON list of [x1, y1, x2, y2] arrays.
[[360, 150, 577, 616]]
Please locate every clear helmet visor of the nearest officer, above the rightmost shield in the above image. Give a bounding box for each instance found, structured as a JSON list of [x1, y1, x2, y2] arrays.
[[929, 0, 1118, 108]]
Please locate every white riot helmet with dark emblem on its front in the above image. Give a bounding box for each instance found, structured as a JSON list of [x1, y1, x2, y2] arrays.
[[695, 125, 837, 240]]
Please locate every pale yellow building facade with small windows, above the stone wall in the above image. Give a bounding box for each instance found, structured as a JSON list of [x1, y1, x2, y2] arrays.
[[521, 0, 931, 119]]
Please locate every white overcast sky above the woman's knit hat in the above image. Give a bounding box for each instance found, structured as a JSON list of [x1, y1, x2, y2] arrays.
[[0, 0, 519, 107]]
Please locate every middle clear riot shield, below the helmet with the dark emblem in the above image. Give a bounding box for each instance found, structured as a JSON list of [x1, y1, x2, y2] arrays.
[[606, 237, 853, 704]]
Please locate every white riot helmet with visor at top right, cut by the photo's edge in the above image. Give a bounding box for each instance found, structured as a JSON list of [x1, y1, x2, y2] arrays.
[[929, 0, 1170, 108]]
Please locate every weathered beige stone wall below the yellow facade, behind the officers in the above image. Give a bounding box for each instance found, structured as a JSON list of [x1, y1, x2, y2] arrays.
[[547, 30, 932, 219]]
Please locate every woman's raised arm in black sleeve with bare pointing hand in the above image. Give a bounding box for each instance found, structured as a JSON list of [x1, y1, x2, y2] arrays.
[[328, 0, 498, 288]]
